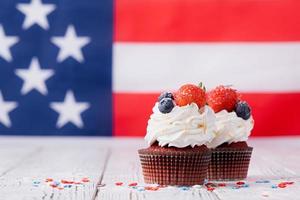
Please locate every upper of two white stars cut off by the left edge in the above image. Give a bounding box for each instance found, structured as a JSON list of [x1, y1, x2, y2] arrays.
[[0, 24, 19, 62]]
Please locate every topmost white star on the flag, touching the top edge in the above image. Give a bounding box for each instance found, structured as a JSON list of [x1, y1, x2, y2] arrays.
[[17, 0, 56, 30]]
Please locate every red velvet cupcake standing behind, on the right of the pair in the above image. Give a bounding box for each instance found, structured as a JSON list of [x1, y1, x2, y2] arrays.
[[207, 86, 254, 180]]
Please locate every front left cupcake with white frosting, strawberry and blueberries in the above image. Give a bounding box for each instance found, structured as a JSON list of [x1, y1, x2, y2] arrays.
[[138, 84, 216, 186]]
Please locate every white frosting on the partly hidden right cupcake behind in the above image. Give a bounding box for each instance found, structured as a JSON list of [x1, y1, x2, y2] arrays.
[[208, 110, 254, 148]]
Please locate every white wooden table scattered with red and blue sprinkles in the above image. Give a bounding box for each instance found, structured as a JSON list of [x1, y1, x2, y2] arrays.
[[0, 137, 300, 200]]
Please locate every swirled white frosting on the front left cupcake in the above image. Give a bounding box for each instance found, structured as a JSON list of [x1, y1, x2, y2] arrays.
[[145, 103, 216, 148]]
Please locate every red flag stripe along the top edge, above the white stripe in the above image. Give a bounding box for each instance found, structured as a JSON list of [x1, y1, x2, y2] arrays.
[[114, 0, 300, 42]]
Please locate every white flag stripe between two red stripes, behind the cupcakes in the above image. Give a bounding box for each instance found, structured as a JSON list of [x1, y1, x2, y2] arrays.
[[113, 42, 300, 92]]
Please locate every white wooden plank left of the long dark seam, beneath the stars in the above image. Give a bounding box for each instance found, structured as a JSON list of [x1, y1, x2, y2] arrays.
[[0, 139, 107, 200]]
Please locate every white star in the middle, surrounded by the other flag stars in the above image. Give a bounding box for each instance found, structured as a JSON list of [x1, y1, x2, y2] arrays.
[[15, 58, 54, 95]]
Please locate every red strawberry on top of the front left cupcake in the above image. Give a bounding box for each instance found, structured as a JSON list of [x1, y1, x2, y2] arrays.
[[175, 84, 206, 108]]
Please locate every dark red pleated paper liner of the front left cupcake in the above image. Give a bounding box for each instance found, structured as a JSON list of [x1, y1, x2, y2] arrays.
[[139, 149, 211, 186]]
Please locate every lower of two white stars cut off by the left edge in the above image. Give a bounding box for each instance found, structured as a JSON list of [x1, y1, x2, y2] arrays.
[[0, 91, 18, 127]]
